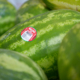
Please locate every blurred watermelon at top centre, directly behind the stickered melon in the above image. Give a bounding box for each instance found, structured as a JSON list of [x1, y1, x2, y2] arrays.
[[16, 0, 49, 23]]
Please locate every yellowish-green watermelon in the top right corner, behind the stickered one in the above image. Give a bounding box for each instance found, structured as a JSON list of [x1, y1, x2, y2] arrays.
[[43, 0, 80, 11]]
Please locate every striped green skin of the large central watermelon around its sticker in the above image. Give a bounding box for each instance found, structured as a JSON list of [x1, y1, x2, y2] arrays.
[[0, 10, 80, 80]]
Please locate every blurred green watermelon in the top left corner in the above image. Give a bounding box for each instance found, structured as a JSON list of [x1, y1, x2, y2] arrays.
[[0, 0, 16, 36]]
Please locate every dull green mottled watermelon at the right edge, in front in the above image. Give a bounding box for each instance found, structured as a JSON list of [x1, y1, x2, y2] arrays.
[[58, 23, 80, 80]]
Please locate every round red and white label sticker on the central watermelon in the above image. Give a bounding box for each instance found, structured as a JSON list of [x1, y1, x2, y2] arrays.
[[21, 27, 37, 41]]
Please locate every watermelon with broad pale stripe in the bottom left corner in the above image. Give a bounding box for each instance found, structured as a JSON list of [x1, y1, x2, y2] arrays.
[[0, 49, 47, 80]]
